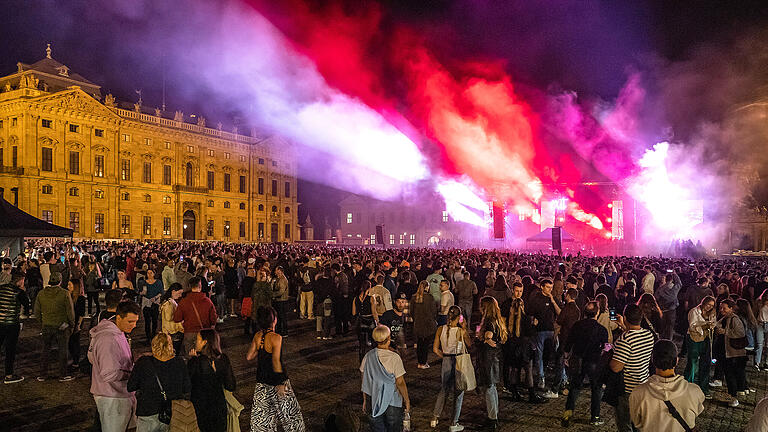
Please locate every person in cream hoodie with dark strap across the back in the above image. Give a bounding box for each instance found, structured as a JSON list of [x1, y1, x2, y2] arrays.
[[629, 339, 704, 432]]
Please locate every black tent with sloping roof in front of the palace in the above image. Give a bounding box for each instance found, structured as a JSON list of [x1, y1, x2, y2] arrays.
[[0, 197, 72, 257]]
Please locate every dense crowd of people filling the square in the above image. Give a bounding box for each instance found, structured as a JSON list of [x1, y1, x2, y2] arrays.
[[0, 241, 768, 432]]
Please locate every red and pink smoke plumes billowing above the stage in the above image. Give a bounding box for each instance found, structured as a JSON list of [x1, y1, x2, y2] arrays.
[[251, 0, 620, 233]]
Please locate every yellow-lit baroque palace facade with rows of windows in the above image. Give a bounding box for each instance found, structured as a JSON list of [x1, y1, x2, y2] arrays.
[[0, 46, 298, 242]]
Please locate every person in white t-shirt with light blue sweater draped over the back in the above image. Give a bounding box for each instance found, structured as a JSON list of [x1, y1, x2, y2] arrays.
[[360, 325, 411, 432]]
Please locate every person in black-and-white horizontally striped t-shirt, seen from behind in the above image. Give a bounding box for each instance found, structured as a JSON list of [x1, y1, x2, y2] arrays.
[[610, 304, 654, 432]]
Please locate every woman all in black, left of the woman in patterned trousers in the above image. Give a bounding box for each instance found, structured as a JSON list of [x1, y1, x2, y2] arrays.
[[187, 329, 236, 432]]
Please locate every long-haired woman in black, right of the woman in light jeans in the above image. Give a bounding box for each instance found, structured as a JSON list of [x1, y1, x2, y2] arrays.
[[502, 298, 543, 403]]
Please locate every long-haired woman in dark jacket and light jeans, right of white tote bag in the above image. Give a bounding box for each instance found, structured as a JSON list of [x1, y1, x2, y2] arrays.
[[477, 296, 507, 430]]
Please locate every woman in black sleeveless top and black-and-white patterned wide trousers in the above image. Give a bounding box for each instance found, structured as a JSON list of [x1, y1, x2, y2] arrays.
[[245, 307, 305, 432]]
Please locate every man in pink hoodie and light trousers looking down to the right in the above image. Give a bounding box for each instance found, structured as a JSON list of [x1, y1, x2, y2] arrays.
[[88, 301, 141, 432]]
